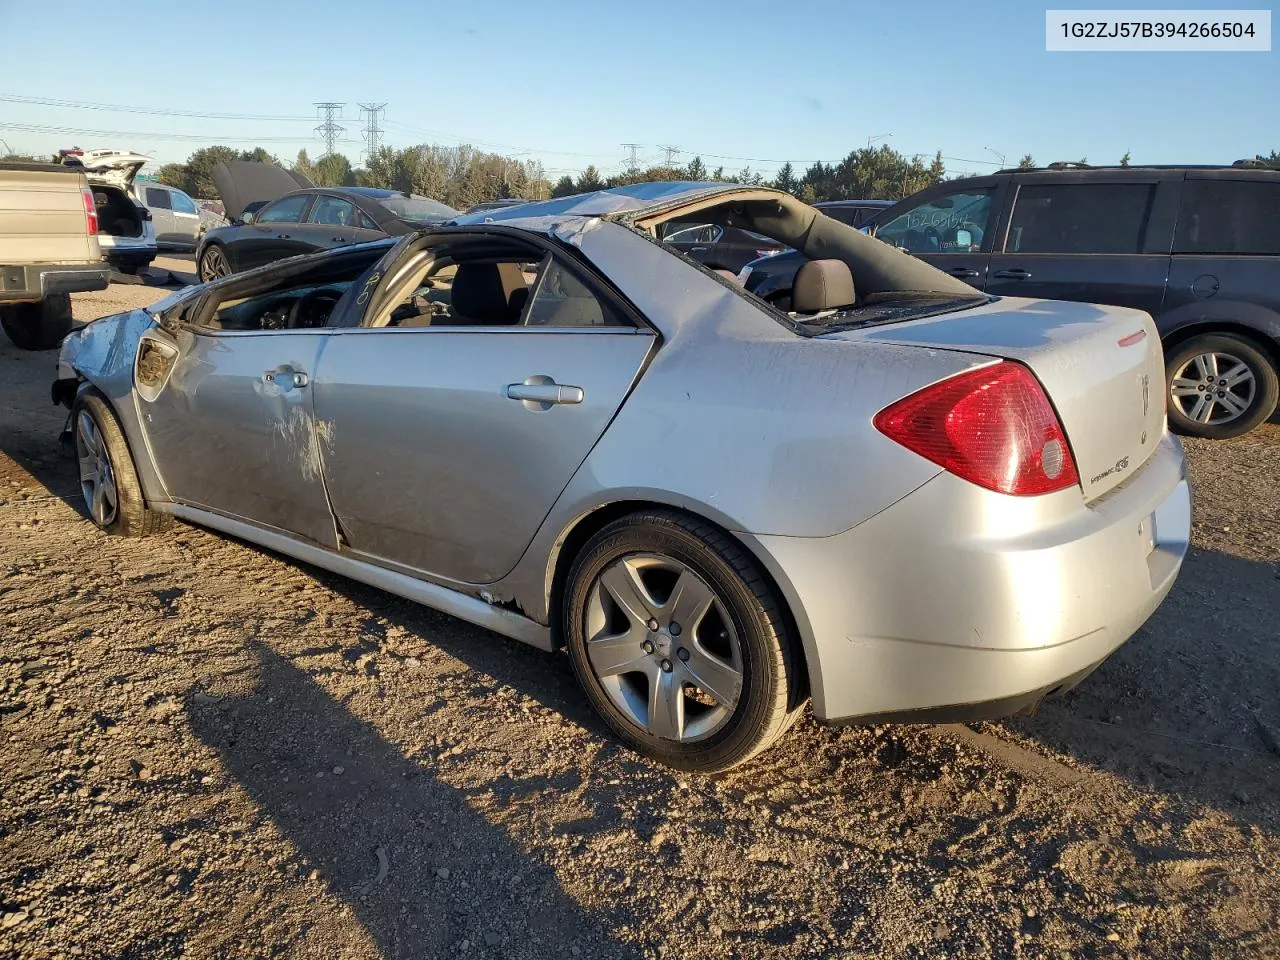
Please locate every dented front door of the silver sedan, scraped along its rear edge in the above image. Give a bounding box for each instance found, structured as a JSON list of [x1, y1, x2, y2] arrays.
[[137, 330, 337, 547]]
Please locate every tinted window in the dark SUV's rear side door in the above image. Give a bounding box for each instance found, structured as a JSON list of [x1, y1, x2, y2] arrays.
[[1005, 183, 1156, 253]]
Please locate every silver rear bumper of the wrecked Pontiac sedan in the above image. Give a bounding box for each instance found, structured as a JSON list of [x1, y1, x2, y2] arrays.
[[745, 436, 1192, 722]]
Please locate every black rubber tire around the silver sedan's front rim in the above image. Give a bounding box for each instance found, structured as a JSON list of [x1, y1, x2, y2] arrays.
[[72, 388, 173, 536]]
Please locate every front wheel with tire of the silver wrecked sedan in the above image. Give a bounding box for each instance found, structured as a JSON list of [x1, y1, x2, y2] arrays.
[[72, 389, 172, 536]]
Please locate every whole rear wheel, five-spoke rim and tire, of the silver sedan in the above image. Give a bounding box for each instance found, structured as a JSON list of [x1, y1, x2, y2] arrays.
[[564, 512, 803, 772]]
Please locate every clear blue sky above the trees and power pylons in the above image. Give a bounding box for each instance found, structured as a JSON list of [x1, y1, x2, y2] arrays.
[[0, 0, 1280, 179]]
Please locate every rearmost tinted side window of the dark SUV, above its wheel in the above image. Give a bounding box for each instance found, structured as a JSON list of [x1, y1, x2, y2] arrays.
[[1174, 180, 1280, 256]]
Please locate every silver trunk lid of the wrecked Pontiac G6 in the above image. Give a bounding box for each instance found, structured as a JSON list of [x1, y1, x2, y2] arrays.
[[828, 297, 1165, 500]]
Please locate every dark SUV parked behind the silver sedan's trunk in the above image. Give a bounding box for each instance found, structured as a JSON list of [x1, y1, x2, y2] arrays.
[[745, 161, 1280, 439]]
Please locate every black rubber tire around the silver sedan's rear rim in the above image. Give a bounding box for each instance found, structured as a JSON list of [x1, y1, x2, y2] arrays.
[[562, 511, 805, 773]]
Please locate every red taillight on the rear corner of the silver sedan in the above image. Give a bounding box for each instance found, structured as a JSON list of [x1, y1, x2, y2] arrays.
[[874, 361, 1079, 497]]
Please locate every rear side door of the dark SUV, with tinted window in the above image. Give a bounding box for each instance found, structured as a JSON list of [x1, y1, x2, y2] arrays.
[[987, 170, 1180, 314]]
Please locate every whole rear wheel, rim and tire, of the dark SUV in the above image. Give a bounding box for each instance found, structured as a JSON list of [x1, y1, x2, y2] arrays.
[[1165, 334, 1280, 440]]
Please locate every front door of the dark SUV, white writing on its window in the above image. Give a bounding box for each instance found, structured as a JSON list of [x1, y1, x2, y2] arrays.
[[876, 177, 1009, 289]]
